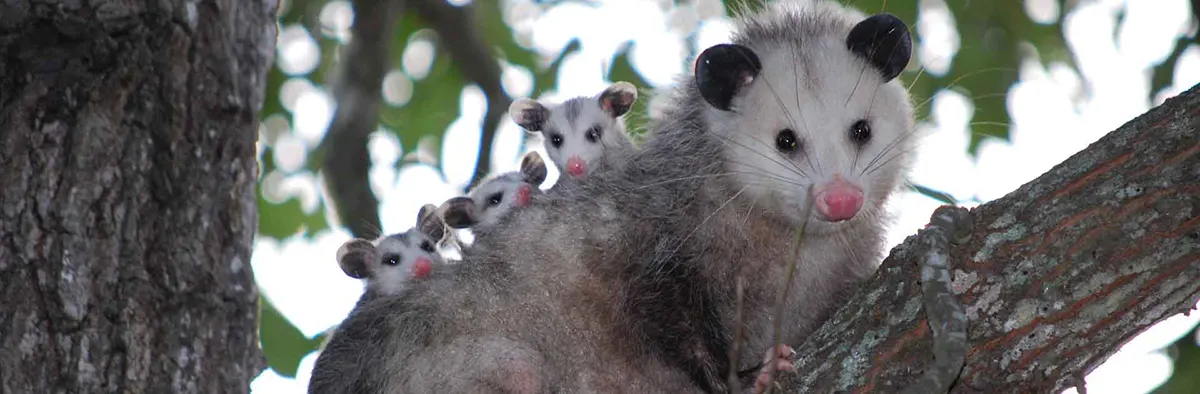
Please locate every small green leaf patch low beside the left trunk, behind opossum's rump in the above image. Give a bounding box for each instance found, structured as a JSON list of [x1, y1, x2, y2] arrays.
[[258, 296, 322, 377]]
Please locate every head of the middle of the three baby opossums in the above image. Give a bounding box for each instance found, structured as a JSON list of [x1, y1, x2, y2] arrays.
[[439, 151, 547, 231]]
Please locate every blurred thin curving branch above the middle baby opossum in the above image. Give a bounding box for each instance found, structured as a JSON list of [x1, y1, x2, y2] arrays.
[[412, 0, 512, 189]]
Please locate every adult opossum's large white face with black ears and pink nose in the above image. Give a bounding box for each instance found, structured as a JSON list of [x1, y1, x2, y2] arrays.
[[695, 2, 913, 232]]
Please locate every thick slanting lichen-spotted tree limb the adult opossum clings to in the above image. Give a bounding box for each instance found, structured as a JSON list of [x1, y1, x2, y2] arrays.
[[782, 85, 1200, 393]]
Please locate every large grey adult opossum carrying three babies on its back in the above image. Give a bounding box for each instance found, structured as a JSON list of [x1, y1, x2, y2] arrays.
[[311, 1, 913, 393]]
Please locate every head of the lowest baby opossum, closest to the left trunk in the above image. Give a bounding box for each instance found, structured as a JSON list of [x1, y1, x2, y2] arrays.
[[337, 204, 448, 294]]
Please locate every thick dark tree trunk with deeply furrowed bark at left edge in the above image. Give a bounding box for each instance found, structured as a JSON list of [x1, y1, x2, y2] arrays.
[[0, 0, 277, 393]]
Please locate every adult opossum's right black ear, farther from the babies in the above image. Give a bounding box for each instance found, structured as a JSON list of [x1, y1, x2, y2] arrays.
[[846, 13, 912, 82]]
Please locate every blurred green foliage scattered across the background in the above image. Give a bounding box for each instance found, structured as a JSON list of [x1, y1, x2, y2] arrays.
[[248, 0, 1200, 384]]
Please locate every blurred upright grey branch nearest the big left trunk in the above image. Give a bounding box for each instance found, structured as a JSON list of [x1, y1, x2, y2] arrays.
[[319, 0, 401, 239]]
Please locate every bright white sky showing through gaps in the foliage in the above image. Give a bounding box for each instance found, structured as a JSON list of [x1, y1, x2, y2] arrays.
[[251, 0, 1200, 393]]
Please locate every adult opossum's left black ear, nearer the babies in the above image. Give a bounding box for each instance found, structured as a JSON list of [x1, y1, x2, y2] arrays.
[[695, 43, 762, 111]]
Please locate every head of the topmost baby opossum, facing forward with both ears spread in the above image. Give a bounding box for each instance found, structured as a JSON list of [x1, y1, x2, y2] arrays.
[[509, 82, 637, 178]]
